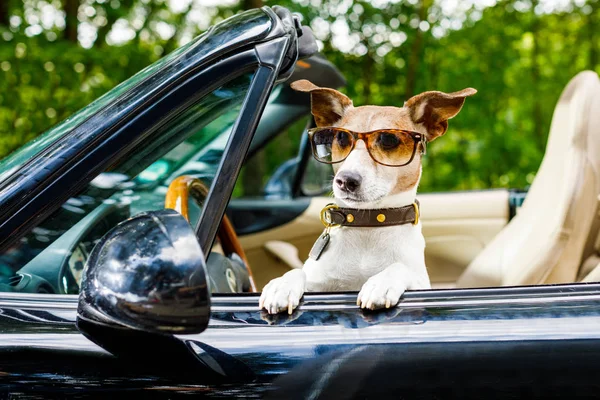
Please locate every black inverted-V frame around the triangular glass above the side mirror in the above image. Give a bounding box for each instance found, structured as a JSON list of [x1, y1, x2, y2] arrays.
[[0, 14, 297, 300]]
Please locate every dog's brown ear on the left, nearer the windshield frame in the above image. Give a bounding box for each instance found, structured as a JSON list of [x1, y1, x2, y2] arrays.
[[290, 79, 352, 126]]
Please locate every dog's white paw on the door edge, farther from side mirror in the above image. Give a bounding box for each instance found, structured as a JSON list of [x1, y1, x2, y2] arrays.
[[356, 271, 406, 310]]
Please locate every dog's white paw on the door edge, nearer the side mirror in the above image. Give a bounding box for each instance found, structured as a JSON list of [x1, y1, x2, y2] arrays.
[[258, 270, 304, 315]]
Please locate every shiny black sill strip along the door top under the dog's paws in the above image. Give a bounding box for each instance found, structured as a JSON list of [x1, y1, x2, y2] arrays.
[[0, 282, 600, 320]]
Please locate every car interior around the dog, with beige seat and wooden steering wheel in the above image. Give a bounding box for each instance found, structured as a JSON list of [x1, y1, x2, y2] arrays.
[[0, 57, 600, 294]]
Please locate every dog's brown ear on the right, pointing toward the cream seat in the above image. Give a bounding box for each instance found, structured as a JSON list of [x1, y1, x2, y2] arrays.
[[404, 88, 477, 141]]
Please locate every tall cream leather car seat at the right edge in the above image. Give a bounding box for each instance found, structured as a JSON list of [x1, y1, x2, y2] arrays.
[[457, 71, 600, 287]]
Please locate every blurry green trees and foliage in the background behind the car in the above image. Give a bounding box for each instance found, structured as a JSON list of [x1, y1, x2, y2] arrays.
[[0, 0, 600, 193]]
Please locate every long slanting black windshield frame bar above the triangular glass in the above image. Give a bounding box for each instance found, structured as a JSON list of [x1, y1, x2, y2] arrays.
[[0, 48, 260, 255]]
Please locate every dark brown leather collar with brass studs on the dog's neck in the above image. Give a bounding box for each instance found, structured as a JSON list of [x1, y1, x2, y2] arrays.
[[321, 200, 420, 227]]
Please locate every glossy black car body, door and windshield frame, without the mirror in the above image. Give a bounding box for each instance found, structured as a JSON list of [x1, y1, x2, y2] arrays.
[[0, 8, 600, 399]]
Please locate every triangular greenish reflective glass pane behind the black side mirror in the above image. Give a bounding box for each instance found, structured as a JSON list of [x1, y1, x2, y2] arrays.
[[0, 73, 253, 294]]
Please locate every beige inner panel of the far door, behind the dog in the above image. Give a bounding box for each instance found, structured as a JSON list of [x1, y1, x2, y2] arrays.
[[240, 190, 509, 289]]
